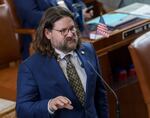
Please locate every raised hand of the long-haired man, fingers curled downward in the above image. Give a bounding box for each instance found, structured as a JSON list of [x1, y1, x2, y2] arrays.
[[49, 96, 73, 112]]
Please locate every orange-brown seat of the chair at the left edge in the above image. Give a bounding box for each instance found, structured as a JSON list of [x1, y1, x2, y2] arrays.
[[0, 65, 18, 101]]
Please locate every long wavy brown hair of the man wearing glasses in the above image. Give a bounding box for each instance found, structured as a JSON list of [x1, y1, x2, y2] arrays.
[[33, 6, 80, 56]]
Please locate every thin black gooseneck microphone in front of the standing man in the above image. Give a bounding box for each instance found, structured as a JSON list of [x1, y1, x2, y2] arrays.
[[87, 60, 120, 118]]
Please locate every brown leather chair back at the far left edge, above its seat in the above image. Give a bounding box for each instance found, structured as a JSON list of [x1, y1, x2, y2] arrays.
[[0, 4, 20, 67]]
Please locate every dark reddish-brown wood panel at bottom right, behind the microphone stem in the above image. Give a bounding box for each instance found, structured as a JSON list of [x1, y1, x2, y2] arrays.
[[109, 81, 148, 118]]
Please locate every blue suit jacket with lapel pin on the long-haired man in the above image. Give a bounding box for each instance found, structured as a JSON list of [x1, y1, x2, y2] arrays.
[[16, 43, 108, 118]]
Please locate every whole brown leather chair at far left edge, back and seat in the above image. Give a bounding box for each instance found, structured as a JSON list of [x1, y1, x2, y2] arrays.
[[0, 4, 21, 100]]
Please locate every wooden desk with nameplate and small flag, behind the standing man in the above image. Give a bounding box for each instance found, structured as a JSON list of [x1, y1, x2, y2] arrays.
[[83, 19, 150, 82]]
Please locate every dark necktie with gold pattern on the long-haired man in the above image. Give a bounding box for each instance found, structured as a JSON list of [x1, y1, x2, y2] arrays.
[[65, 55, 85, 106]]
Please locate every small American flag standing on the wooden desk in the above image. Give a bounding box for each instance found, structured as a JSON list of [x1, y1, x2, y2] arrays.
[[96, 16, 109, 37]]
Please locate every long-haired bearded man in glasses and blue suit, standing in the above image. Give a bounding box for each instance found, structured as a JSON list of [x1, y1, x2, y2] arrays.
[[16, 7, 108, 118]]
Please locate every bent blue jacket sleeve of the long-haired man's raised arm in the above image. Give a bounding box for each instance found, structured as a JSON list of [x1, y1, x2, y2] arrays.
[[16, 64, 52, 118]]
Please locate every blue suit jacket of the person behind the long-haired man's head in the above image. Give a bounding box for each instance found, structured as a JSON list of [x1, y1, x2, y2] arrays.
[[14, 0, 85, 28]]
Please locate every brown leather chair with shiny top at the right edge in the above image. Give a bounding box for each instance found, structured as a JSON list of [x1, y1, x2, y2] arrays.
[[128, 32, 150, 118]]
